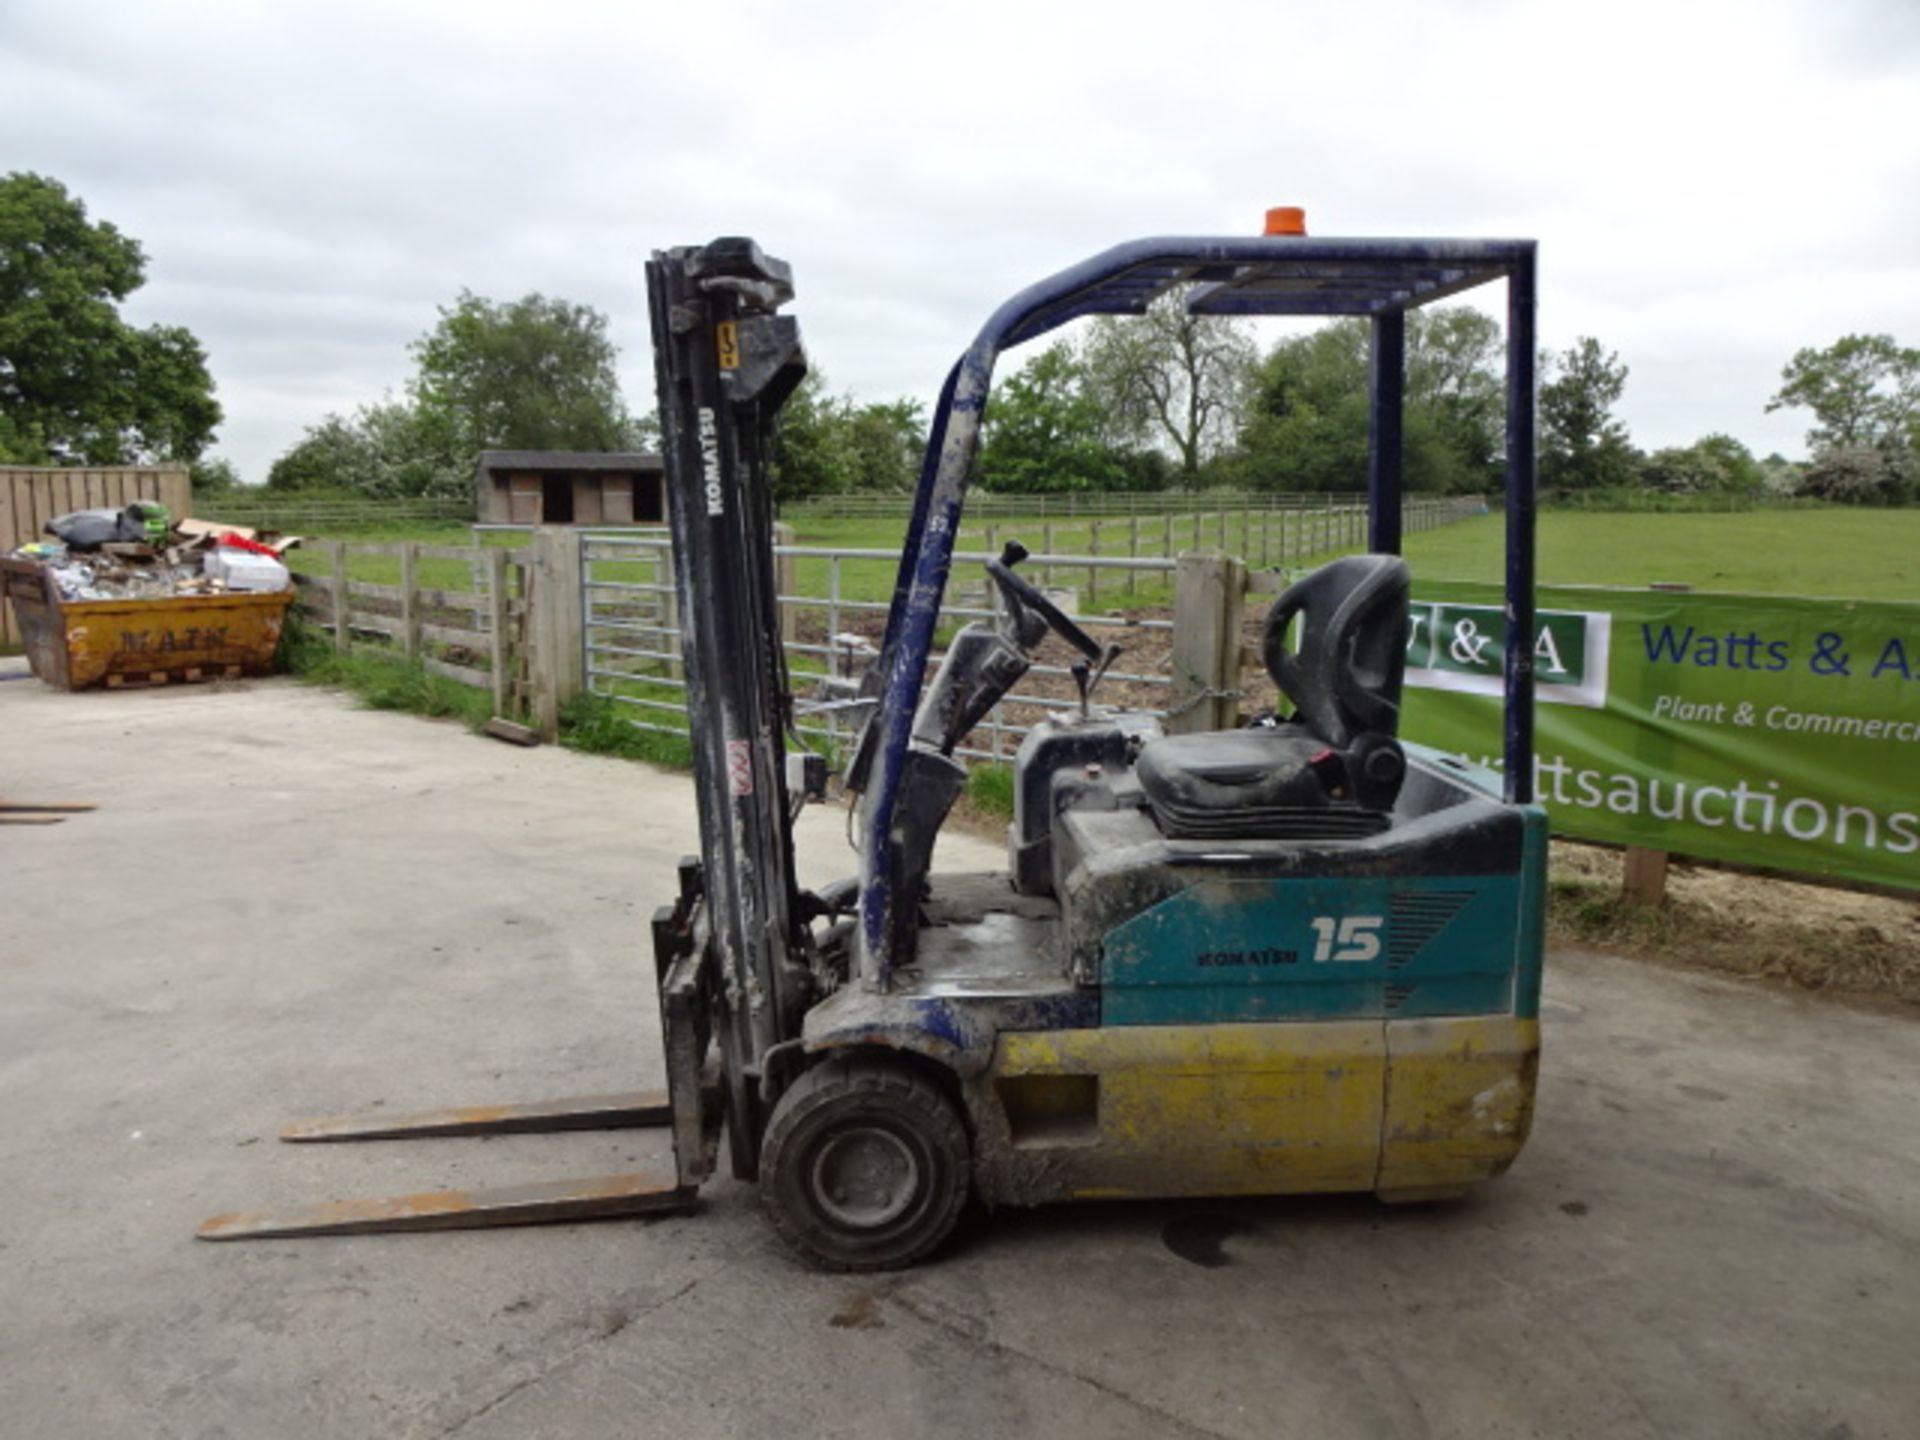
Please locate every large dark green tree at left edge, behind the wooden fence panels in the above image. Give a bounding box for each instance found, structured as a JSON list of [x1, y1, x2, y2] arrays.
[[0, 171, 221, 465]]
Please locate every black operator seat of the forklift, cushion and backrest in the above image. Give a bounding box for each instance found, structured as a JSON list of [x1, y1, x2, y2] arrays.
[[1135, 555, 1409, 839]]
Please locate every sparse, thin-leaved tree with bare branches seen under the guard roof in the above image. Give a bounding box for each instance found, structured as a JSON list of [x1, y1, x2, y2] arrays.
[[1085, 292, 1256, 488]]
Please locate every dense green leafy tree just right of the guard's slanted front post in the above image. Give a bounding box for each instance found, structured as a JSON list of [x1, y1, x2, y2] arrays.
[[979, 340, 1131, 495]]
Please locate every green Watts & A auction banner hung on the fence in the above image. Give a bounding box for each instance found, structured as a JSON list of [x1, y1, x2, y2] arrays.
[[1402, 582, 1920, 889]]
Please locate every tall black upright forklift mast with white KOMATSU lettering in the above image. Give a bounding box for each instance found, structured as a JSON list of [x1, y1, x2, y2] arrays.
[[647, 238, 810, 1135]]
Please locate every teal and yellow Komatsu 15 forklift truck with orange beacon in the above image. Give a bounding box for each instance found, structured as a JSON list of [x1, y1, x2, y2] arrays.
[[202, 211, 1546, 1269]]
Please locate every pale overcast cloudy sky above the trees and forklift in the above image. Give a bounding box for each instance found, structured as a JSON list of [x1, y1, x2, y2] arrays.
[[0, 0, 1920, 480]]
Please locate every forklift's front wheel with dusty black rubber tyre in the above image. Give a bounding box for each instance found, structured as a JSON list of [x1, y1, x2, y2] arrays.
[[760, 1060, 972, 1271]]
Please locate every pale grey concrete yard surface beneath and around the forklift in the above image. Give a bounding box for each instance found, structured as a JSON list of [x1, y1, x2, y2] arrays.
[[0, 662, 1920, 1440]]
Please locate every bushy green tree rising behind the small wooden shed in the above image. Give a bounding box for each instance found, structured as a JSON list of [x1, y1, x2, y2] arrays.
[[411, 290, 632, 463]]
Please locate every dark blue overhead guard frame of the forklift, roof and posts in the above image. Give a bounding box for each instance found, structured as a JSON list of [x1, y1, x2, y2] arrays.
[[856, 236, 1538, 989]]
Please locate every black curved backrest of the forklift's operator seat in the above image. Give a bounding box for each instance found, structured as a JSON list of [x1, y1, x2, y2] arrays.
[[1261, 555, 1411, 749]]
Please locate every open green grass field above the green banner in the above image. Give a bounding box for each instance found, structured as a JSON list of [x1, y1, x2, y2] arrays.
[[1407, 507, 1920, 599]]
